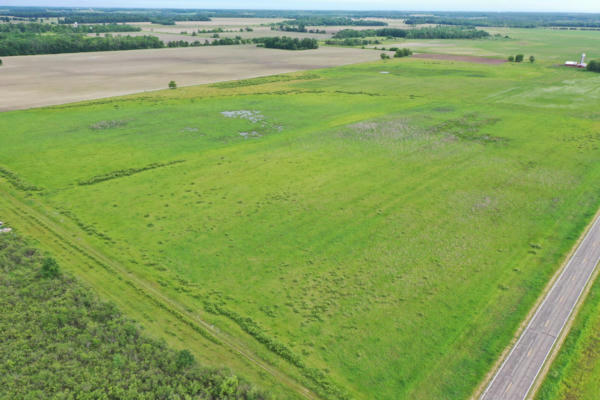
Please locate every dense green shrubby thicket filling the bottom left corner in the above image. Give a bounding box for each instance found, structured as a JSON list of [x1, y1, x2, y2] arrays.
[[0, 234, 267, 400]]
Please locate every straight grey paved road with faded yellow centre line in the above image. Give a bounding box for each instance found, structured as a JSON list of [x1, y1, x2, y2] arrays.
[[481, 217, 600, 400]]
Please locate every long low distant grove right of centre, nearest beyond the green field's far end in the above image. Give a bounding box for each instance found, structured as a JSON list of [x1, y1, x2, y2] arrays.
[[333, 26, 490, 39]]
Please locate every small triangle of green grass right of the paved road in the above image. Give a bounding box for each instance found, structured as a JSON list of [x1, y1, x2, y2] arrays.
[[537, 276, 600, 400]]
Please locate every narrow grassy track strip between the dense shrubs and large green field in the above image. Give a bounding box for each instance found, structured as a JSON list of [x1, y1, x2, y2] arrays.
[[2, 186, 320, 400]]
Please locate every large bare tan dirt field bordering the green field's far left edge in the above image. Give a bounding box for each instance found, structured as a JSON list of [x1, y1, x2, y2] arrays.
[[0, 45, 379, 111]]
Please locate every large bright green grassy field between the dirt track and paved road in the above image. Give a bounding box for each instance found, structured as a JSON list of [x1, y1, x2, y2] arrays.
[[0, 59, 600, 399]]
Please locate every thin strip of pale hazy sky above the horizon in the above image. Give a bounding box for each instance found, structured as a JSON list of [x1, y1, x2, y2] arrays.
[[0, 0, 600, 12]]
